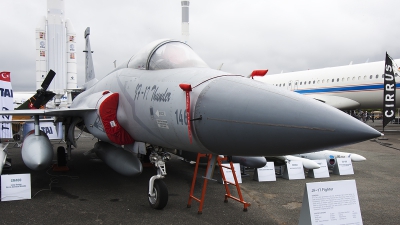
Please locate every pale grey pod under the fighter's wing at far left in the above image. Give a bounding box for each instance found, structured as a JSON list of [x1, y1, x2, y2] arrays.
[[21, 130, 53, 170]]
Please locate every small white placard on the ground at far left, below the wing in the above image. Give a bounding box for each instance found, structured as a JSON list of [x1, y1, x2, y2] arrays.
[[1, 173, 31, 201]]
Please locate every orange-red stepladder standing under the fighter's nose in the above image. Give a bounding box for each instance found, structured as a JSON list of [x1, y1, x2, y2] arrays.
[[187, 153, 250, 214]]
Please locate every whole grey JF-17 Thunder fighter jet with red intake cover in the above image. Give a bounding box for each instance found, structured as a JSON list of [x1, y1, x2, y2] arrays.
[[3, 28, 381, 209]]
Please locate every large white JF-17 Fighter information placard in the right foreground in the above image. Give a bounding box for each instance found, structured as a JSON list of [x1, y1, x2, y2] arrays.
[[299, 180, 363, 225]]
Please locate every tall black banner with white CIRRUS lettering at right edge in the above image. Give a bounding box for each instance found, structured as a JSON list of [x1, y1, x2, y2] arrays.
[[383, 52, 396, 128]]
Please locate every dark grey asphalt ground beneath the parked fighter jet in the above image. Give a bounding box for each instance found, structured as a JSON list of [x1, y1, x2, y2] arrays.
[[0, 121, 400, 224]]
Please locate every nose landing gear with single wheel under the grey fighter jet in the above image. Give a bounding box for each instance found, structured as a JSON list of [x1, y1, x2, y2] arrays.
[[149, 148, 171, 209]]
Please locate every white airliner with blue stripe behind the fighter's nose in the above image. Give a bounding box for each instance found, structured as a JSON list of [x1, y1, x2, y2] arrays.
[[255, 59, 400, 109]]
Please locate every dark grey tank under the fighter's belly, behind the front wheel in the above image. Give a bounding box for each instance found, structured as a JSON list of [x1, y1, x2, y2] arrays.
[[93, 141, 143, 176]]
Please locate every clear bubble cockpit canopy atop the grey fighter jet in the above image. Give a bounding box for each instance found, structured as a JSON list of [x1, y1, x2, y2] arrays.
[[128, 40, 208, 70]]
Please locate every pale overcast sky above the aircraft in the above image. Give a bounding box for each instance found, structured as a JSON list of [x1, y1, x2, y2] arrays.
[[0, 0, 400, 91]]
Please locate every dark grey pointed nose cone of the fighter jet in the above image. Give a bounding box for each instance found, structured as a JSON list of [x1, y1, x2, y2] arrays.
[[193, 77, 381, 156]]
